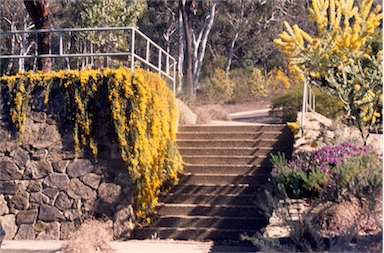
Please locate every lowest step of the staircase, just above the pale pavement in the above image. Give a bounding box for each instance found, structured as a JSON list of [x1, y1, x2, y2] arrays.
[[133, 227, 258, 241]]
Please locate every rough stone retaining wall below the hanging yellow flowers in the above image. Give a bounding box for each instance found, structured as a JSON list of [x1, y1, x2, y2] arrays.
[[0, 84, 134, 240]]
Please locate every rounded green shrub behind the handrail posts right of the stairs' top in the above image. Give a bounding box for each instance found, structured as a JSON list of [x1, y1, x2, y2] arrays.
[[271, 85, 343, 122]]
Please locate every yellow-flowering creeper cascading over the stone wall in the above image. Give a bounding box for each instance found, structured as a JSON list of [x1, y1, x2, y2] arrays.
[[1, 67, 182, 222]]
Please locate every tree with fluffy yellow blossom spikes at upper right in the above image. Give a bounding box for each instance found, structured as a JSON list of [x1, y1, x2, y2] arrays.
[[274, 0, 383, 142]]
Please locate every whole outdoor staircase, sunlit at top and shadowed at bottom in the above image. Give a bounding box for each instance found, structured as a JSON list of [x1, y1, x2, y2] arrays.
[[134, 125, 293, 242]]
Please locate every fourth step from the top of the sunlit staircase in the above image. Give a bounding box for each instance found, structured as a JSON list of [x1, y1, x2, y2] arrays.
[[179, 147, 292, 156]]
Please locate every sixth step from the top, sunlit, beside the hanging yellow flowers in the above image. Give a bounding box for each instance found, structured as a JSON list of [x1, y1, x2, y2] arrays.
[[183, 164, 272, 175]]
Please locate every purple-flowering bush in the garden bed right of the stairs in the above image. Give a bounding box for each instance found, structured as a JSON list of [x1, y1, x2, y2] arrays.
[[271, 142, 382, 200]]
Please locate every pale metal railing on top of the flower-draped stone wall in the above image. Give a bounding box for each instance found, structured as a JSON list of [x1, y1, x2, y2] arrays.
[[0, 27, 176, 93]]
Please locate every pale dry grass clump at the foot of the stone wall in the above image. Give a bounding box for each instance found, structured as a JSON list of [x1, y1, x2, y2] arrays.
[[60, 219, 116, 253]]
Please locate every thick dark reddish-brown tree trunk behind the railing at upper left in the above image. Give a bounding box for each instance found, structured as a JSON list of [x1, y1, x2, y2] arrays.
[[24, 0, 52, 72]]
